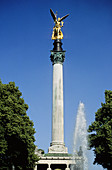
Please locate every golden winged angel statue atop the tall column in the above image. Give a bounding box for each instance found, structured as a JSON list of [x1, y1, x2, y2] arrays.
[[50, 9, 69, 40]]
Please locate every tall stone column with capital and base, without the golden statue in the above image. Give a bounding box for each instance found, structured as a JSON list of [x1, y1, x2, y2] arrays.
[[49, 40, 68, 153]]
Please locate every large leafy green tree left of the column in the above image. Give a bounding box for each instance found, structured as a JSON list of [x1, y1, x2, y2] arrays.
[[0, 81, 38, 170]]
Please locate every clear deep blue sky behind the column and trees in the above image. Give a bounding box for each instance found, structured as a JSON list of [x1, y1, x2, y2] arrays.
[[0, 0, 112, 170]]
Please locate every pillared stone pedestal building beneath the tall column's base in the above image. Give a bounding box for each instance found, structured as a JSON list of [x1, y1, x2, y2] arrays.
[[35, 153, 83, 170]]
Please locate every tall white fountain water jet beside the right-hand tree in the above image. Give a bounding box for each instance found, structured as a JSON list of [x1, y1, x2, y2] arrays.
[[71, 102, 88, 170]]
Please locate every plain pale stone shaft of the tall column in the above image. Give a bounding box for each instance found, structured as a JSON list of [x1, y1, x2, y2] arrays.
[[52, 63, 64, 145]]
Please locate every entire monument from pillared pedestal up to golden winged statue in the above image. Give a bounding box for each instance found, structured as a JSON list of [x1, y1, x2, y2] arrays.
[[35, 9, 83, 170]]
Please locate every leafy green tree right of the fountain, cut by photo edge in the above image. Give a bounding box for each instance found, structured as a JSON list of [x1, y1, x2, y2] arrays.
[[88, 90, 112, 170]]
